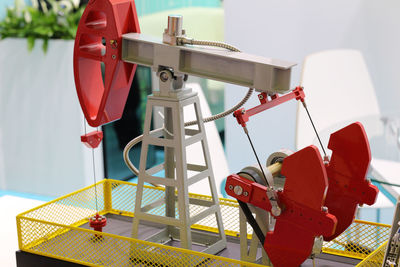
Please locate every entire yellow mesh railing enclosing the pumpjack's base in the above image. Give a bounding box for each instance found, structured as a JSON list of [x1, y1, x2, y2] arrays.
[[17, 179, 390, 266]]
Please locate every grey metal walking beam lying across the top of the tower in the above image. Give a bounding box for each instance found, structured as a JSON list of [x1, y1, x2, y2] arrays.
[[122, 33, 296, 94]]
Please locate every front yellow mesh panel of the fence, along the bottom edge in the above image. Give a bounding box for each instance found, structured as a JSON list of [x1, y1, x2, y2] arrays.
[[21, 219, 268, 266]]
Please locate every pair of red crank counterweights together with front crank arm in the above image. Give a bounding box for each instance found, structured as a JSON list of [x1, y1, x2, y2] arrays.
[[225, 122, 378, 267]]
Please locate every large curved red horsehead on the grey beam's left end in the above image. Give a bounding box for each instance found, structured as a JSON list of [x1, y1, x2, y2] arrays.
[[74, 0, 140, 127]]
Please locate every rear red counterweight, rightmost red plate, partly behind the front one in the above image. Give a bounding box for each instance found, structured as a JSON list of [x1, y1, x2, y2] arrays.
[[324, 122, 378, 241]]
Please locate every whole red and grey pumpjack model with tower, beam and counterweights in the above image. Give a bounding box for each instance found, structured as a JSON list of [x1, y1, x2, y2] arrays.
[[74, 0, 378, 267]]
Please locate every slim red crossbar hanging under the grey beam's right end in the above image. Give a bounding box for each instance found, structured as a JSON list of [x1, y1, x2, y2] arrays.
[[233, 86, 305, 127]]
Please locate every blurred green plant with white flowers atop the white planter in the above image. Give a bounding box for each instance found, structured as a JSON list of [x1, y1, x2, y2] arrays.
[[0, 0, 84, 52]]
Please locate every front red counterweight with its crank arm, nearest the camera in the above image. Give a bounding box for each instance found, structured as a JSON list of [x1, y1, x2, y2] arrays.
[[225, 146, 337, 267]]
